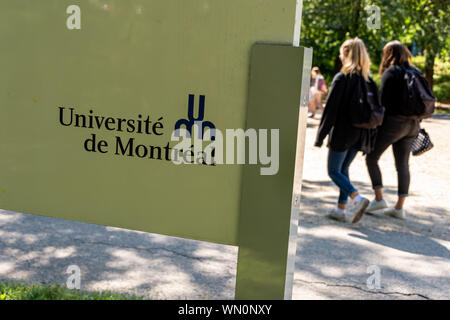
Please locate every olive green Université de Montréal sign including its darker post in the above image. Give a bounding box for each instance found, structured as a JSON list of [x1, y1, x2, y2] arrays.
[[0, 0, 311, 299]]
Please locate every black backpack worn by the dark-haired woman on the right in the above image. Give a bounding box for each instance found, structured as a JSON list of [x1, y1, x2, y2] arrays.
[[402, 66, 437, 120]]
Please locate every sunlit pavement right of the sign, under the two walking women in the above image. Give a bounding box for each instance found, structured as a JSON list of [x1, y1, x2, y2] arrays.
[[294, 115, 450, 299]]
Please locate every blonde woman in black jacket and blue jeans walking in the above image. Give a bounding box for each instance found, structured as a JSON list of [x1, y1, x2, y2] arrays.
[[315, 38, 378, 223]]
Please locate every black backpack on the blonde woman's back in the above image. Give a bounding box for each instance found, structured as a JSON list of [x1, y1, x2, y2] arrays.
[[350, 77, 385, 129]]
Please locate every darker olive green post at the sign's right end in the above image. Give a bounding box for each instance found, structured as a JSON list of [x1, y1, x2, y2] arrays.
[[236, 45, 312, 299]]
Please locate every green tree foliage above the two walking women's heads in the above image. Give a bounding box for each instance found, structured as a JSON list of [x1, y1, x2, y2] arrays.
[[301, 0, 450, 87]]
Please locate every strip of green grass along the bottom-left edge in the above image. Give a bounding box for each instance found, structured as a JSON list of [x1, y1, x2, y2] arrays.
[[0, 281, 141, 300]]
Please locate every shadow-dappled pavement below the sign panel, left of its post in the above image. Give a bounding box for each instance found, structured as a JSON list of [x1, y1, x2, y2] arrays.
[[0, 211, 237, 299]]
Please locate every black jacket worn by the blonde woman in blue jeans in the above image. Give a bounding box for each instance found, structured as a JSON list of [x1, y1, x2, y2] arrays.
[[315, 72, 378, 153]]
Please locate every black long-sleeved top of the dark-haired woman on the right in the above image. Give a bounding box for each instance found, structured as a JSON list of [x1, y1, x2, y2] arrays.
[[380, 64, 420, 116]]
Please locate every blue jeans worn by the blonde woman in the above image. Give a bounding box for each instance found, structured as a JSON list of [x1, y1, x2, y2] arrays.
[[328, 149, 358, 204]]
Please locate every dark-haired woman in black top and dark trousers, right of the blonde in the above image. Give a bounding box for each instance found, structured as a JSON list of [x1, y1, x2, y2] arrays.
[[366, 40, 420, 219]]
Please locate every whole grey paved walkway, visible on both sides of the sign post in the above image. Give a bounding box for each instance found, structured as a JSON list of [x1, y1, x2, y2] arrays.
[[0, 115, 450, 299]]
